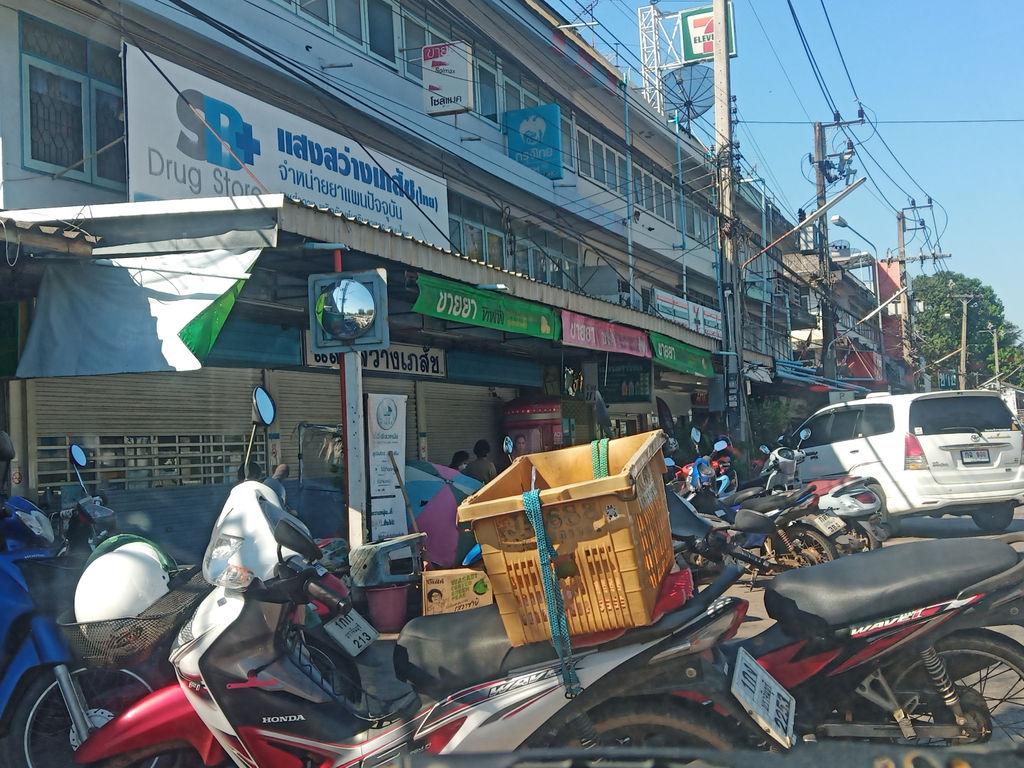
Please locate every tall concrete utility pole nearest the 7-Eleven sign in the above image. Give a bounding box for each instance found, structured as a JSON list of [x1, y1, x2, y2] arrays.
[[712, 0, 746, 440]]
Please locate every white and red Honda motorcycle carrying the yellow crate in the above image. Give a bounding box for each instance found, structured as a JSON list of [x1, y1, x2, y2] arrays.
[[75, 421, 770, 768]]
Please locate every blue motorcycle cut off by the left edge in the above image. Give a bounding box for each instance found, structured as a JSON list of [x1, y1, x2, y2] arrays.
[[0, 432, 151, 768]]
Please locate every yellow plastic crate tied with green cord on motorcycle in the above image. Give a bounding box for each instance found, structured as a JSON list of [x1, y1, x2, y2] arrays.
[[459, 431, 672, 645]]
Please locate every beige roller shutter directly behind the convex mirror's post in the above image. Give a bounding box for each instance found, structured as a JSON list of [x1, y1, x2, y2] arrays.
[[268, 371, 416, 468]]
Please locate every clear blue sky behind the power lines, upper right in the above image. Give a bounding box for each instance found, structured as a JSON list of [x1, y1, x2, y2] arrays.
[[555, 0, 1024, 326]]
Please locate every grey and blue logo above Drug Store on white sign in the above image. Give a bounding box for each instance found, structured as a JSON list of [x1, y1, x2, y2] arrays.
[[176, 89, 260, 171]]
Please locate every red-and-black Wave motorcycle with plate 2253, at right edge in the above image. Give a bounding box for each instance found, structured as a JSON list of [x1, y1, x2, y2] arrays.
[[672, 493, 1024, 749]]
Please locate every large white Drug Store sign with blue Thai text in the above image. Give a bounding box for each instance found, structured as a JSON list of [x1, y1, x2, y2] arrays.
[[125, 45, 449, 246]]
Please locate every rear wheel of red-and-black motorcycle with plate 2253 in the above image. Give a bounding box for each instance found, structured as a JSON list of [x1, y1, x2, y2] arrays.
[[891, 630, 1024, 748]]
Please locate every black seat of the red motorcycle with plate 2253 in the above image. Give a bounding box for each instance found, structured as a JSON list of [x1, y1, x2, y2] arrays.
[[765, 539, 1018, 636]]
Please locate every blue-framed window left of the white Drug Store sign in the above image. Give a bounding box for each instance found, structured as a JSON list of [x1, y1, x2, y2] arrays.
[[19, 13, 126, 189]]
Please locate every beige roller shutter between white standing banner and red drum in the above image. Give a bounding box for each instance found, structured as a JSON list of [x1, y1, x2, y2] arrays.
[[420, 382, 515, 465]]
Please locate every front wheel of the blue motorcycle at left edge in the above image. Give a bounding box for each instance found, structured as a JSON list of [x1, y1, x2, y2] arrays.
[[0, 668, 173, 768]]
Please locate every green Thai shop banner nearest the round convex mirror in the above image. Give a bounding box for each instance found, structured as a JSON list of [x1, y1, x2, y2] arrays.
[[413, 274, 561, 341]]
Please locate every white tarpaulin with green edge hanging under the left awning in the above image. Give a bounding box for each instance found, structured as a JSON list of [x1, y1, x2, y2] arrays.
[[17, 249, 260, 379]]
